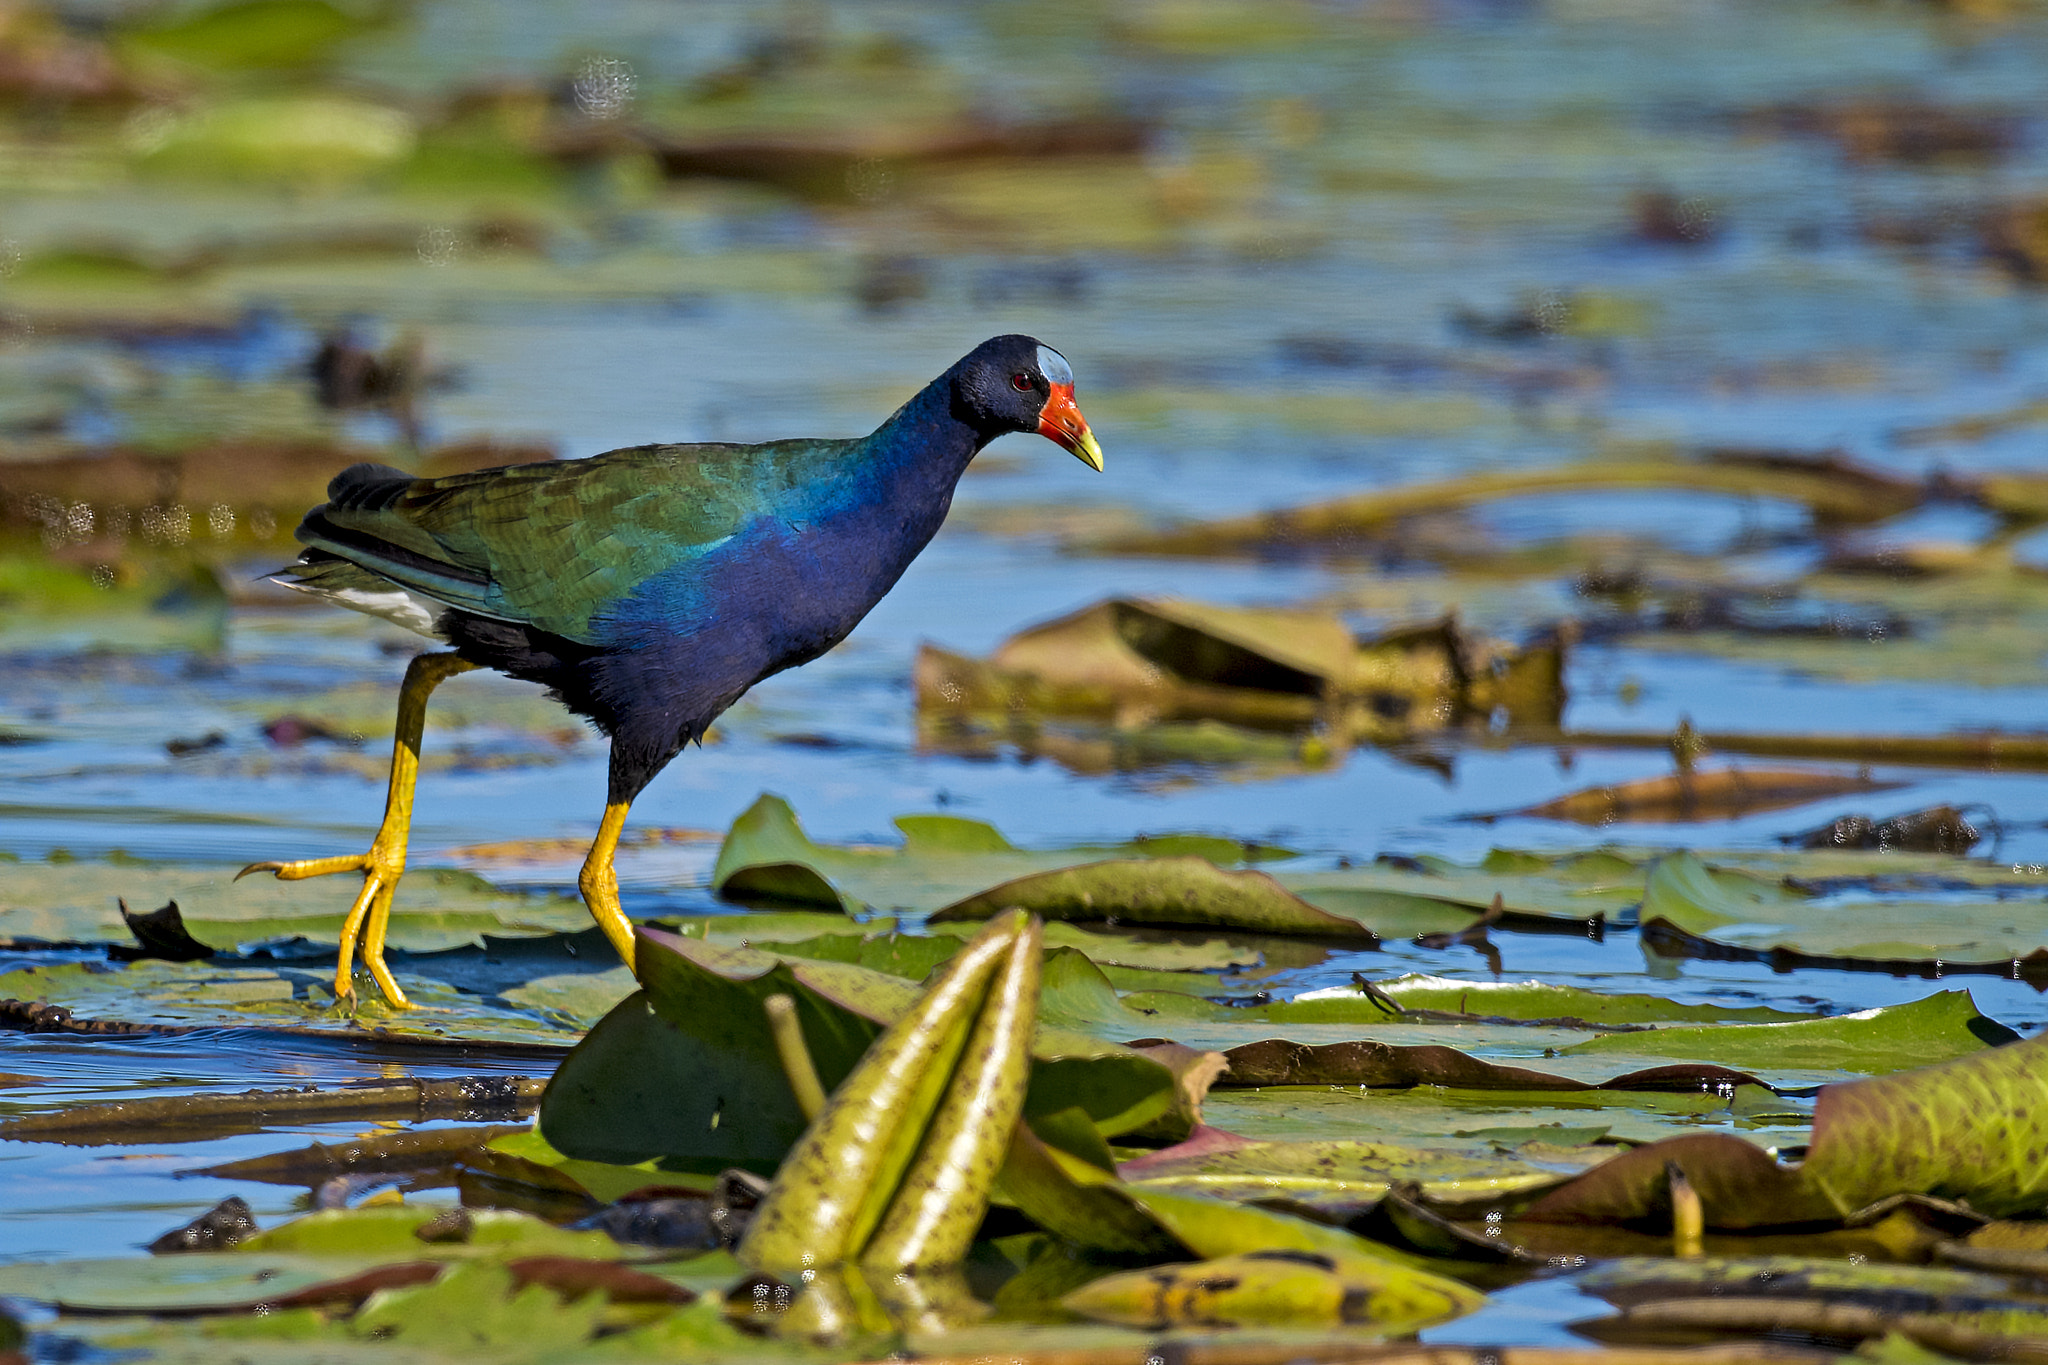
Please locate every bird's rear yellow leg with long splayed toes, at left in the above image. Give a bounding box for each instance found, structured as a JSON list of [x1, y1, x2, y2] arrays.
[[236, 655, 477, 1009]]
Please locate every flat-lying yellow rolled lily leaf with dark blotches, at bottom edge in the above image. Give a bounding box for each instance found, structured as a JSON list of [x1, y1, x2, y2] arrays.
[[1061, 1250, 1464, 1332]]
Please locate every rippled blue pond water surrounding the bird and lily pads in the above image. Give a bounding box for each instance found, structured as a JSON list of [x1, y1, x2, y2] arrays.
[[0, 0, 2048, 1359]]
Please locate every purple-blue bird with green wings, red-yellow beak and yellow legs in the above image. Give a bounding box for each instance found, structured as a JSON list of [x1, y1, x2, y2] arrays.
[[236, 336, 1102, 1009]]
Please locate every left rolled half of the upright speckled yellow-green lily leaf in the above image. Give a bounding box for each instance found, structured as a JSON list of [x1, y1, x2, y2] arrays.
[[737, 913, 1024, 1271]]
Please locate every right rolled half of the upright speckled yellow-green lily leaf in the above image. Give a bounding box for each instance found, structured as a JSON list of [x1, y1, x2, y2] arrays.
[[862, 915, 1044, 1269]]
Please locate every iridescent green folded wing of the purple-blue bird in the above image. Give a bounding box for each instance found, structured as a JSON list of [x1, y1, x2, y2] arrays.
[[299, 442, 831, 643]]
